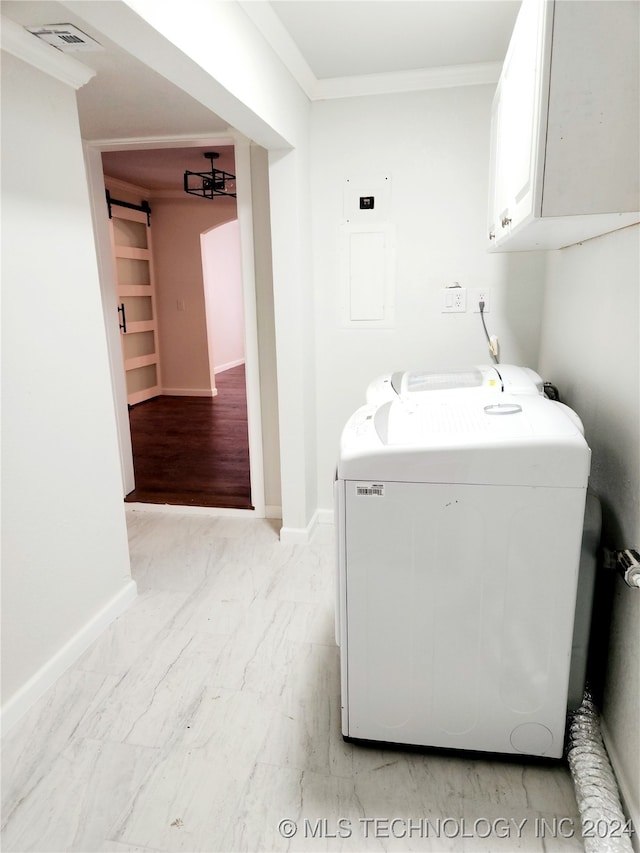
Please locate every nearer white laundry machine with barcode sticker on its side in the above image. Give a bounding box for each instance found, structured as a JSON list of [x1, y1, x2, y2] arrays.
[[336, 391, 590, 758]]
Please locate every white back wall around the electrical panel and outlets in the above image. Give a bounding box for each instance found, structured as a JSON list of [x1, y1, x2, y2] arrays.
[[311, 86, 544, 509]]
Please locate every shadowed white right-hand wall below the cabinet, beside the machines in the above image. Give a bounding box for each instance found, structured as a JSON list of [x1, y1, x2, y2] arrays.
[[540, 225, 640, 827]]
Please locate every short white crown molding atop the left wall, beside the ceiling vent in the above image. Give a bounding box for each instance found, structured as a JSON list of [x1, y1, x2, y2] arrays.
[[0, 15, 96, 89]]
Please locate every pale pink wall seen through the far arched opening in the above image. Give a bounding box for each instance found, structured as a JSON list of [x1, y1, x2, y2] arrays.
[[200, 219, 244, 373]]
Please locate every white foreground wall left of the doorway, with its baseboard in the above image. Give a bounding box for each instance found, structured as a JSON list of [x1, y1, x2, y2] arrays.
[[2, 52, 135, 724]]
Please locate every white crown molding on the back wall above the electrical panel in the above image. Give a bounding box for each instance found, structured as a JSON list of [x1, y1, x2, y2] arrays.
[[313, 62, 502, 101]]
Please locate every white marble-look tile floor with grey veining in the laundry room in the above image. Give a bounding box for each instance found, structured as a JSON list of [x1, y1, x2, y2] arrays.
[[2, 510, 583, 853]]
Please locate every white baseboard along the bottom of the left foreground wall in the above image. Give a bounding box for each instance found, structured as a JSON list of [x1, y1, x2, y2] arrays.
[[0, 580, 137, 735]]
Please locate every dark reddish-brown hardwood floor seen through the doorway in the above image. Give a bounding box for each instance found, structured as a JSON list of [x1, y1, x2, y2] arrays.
[[125, 365, 253, 509]]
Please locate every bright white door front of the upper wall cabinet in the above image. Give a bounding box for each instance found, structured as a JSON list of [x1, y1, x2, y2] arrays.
[[490, 0, 552, 242]]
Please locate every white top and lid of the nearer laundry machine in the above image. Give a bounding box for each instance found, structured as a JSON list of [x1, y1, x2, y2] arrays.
[[338, 392, 590, 487]]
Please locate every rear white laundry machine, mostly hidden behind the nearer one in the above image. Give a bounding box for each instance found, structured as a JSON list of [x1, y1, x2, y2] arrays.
[[366, 364, 544, 404]]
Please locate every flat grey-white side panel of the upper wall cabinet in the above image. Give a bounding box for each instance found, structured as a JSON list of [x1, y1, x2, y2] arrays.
[[542, 0, 640, 216]]
